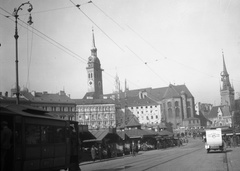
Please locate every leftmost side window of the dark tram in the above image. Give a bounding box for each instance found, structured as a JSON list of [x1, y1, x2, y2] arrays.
[[26, 125, 41, 144]]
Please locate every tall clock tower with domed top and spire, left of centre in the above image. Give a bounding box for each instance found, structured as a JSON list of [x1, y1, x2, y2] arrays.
[[86, 29, 103, 99]]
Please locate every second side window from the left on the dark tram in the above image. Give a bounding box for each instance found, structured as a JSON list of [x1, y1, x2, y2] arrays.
[[41, 126, 54, 144]]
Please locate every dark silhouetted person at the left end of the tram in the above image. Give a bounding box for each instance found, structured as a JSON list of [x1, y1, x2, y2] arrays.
[[1, 121, 12, 171]]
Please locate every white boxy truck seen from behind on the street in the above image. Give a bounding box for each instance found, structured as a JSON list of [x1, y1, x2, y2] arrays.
[[205, 128, 224, 153]]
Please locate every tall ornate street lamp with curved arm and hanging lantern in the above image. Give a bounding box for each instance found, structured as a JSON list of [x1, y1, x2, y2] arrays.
[[13, 2, 33, 105]]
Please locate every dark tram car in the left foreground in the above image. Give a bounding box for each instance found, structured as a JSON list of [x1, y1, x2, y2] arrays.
[[0, 105, 80, 171]]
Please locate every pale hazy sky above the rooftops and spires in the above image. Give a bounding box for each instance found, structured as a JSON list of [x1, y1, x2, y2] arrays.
[[0, 0, 240, 105]]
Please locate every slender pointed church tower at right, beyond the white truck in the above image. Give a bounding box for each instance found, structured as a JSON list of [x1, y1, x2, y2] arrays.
[[220, 52, 234, 110]]
